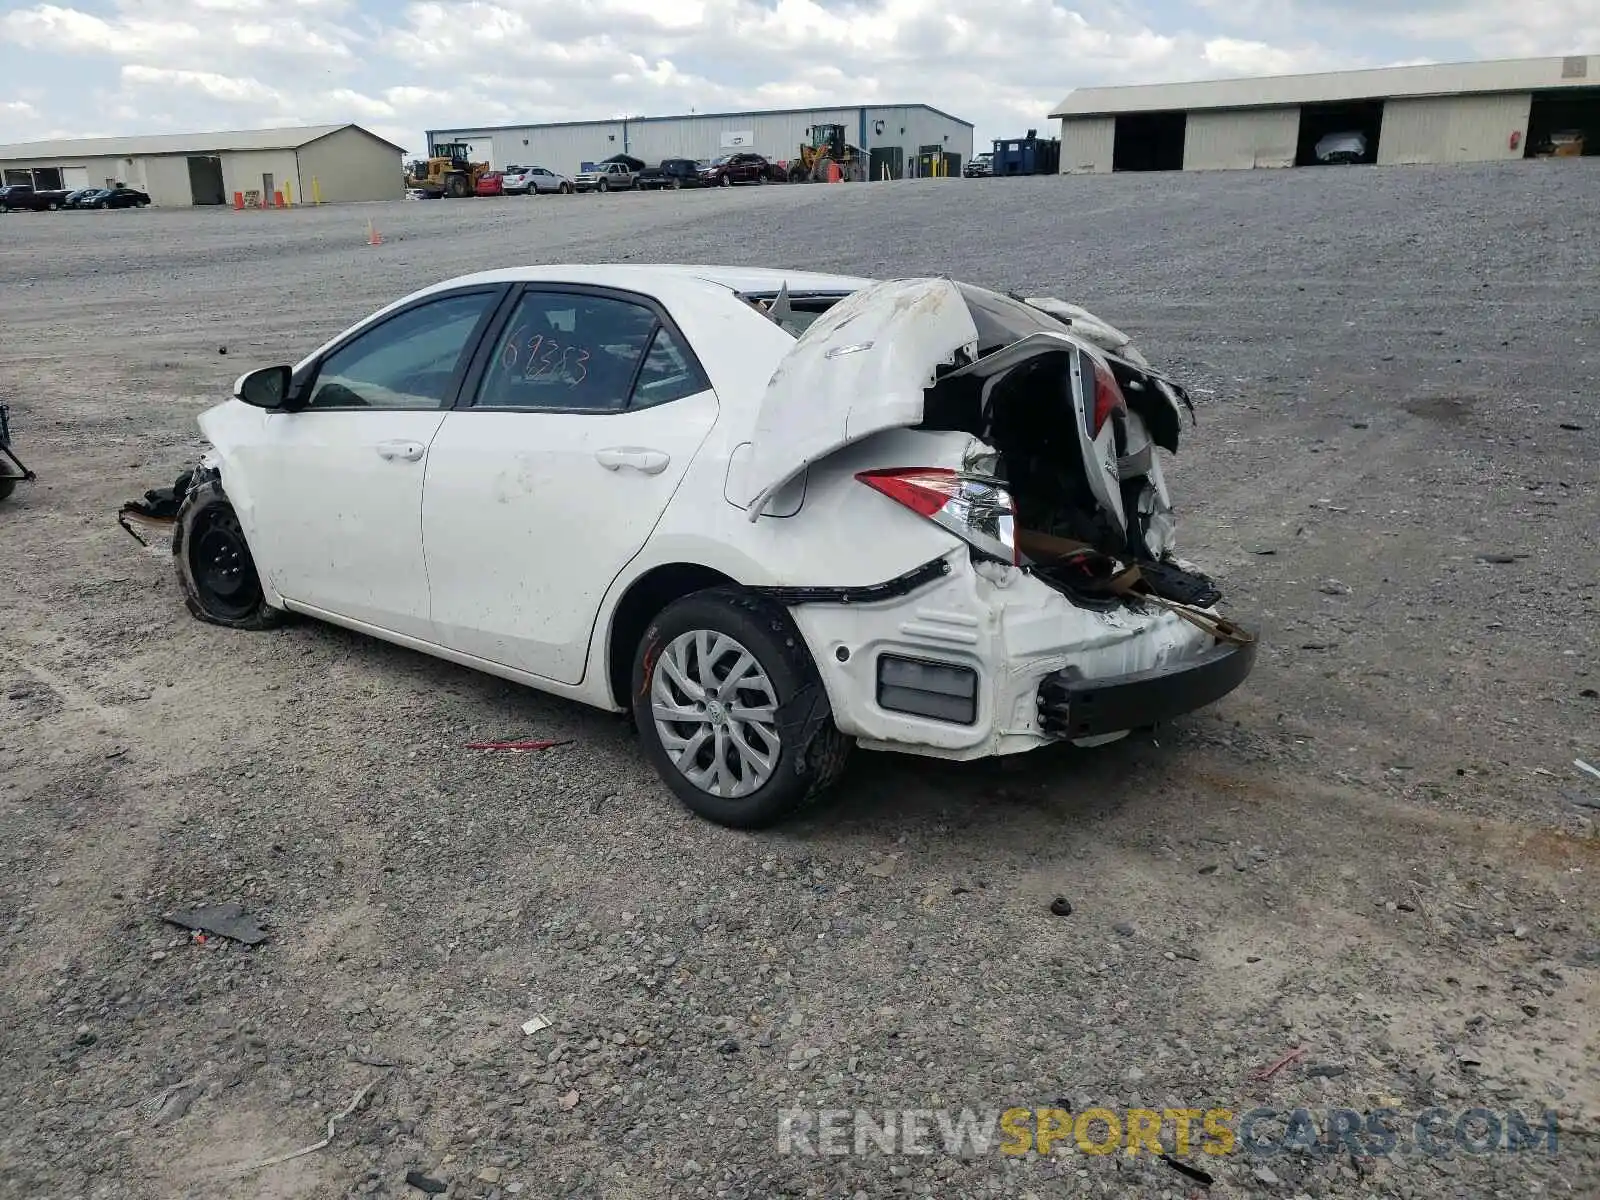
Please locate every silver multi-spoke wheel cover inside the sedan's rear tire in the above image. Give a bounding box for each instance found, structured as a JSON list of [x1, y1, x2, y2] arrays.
[[650, 629, 782, 798]]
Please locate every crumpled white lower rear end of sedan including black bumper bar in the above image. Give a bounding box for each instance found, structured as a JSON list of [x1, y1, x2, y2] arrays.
[[793, 547, 1254, 760]]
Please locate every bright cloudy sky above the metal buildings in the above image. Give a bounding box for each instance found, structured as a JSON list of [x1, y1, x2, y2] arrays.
[[0, 0, 1600, 152]]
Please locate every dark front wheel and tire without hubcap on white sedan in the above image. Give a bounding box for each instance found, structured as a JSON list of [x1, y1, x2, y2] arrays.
[[173, 478, 285, 629]]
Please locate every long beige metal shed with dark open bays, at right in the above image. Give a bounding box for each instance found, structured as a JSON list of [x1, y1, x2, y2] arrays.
[[1050, 56, 1600, 174]]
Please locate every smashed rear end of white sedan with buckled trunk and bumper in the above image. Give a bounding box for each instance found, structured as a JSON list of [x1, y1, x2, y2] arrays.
[[732, 278, 1256, 771]]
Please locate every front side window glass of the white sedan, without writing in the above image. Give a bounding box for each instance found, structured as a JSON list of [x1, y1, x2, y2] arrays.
[[307, 291, 496, 408]]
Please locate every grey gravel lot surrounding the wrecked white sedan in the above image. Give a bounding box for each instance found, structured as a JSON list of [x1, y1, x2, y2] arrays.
[[0, 162, 1600, 1200]]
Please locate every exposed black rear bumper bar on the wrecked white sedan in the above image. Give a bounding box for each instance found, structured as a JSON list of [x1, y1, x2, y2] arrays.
[[1038, 642, 1258, 739]]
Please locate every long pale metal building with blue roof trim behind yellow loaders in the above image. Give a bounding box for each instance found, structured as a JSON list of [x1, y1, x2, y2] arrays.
[[427, 104, 973, 179]]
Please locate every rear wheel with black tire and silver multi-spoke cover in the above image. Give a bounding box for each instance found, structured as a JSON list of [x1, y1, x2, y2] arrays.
[[632, 587, 851, 829]]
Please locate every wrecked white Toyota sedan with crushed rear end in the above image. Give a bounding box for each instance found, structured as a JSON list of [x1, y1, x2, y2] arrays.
[[173, 266, 1256, 827]]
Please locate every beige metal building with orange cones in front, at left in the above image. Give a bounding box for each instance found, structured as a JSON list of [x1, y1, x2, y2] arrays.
[[0, 125, 405, 205]]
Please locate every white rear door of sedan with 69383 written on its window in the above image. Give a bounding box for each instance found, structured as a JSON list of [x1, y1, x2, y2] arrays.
[[422, 286, 717, 683]]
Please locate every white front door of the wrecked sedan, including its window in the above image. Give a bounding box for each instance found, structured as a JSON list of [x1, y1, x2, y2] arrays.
[[235, 288, 502, 642]]
